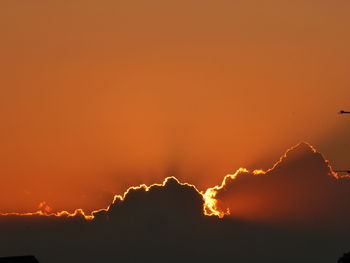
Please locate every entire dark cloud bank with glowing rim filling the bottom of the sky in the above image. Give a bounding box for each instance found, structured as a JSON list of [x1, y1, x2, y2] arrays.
[[0, 143, 350, 263]]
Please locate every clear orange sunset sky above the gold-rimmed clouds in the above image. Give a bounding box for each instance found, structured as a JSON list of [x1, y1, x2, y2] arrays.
[[0, 0, 350, 211]]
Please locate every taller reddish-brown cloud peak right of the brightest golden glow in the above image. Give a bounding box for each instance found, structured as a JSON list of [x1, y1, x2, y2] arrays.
[[216, 143, 350, 227]]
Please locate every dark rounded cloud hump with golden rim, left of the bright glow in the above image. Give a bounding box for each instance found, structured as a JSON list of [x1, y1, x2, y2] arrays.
[[94, 177, 204, 221]]
